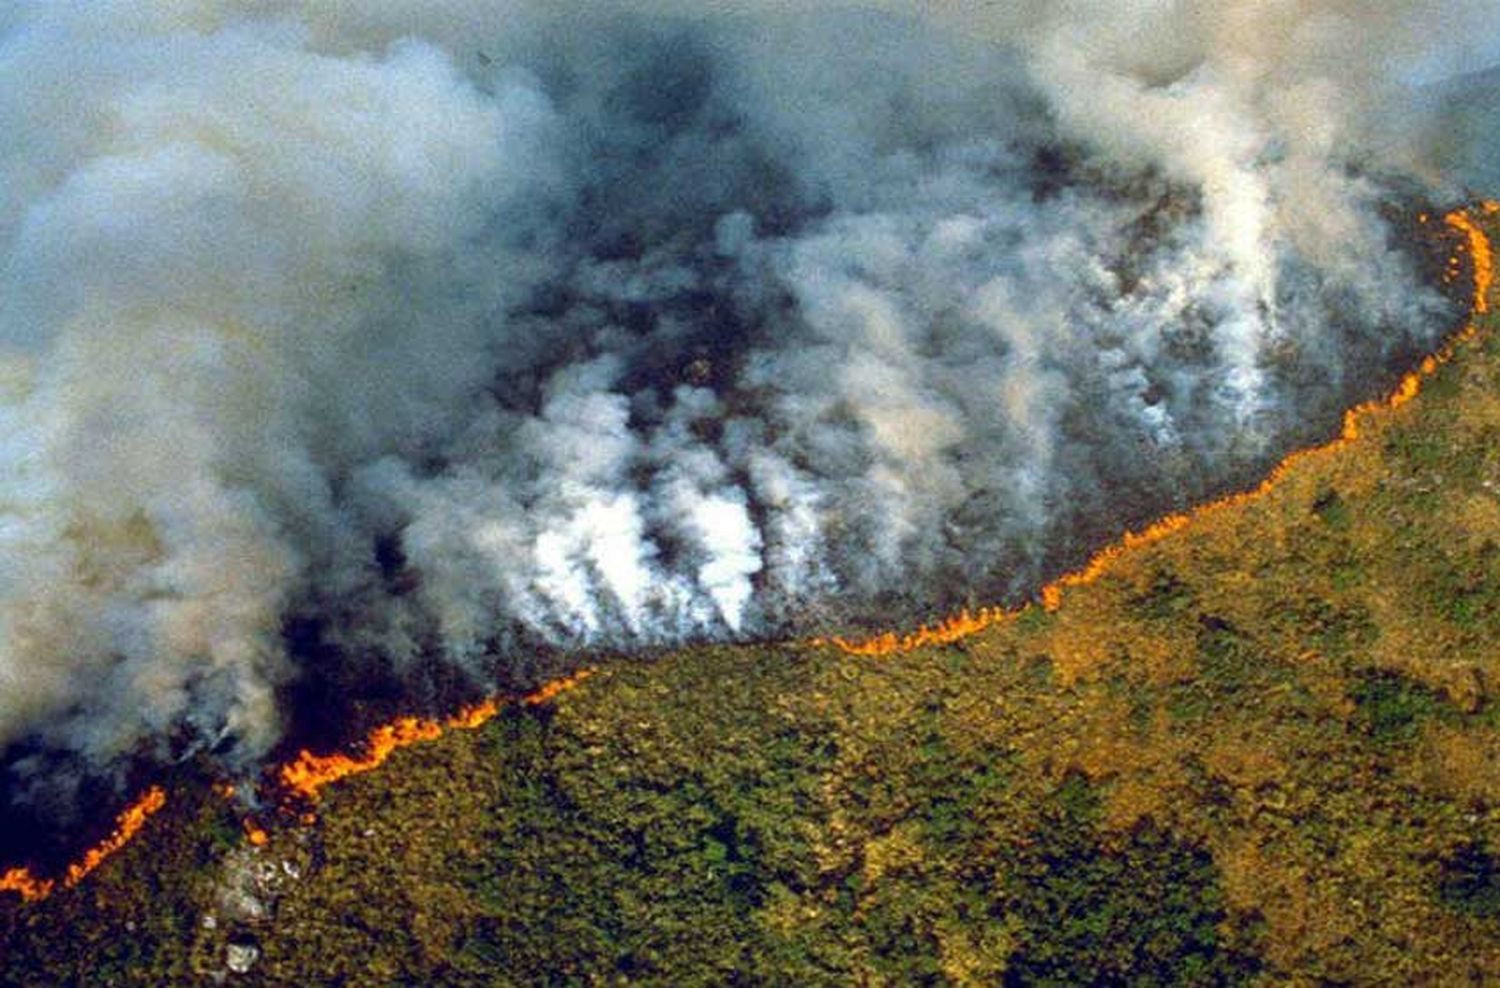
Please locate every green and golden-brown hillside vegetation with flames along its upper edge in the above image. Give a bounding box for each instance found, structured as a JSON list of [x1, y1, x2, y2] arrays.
[[6, 205, 1500, 984]]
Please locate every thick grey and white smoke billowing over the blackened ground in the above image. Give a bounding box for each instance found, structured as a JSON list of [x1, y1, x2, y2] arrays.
[[0, 0, 1496, 809]]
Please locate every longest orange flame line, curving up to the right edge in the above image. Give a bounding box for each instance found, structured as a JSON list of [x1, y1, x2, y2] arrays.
[[813, 201, 1500, 657]]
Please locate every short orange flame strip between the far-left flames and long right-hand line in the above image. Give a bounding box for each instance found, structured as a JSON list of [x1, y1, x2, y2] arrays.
[[276, 669, 594, 809]]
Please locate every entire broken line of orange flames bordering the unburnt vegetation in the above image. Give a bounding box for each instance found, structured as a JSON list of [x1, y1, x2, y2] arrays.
[[0, 201, 1500, 903]]
